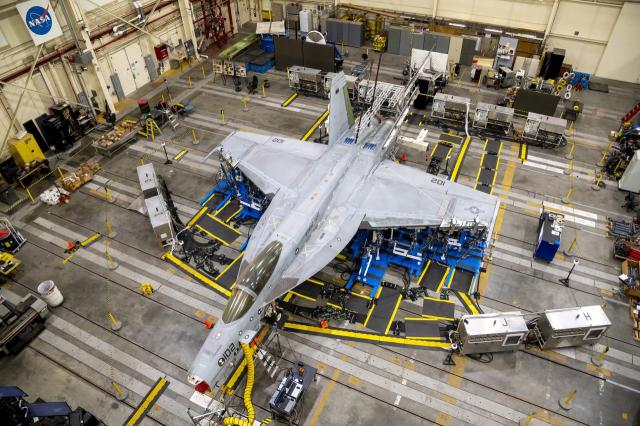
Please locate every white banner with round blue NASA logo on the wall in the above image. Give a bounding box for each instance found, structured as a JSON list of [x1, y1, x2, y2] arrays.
[[16, 0, 62, 46]]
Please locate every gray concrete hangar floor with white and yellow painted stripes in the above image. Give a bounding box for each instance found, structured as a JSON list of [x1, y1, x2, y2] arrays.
[[0, 43, 640, 426]]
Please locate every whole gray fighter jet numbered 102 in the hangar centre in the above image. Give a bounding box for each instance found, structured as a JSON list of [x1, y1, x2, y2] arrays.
[[189, 65, 499, 390]]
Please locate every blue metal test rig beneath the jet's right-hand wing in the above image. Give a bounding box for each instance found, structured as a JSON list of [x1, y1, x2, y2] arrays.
[[346, 220, 487, 297]]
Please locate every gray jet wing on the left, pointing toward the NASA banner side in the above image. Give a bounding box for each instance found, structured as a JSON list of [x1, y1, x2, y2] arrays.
[[217, 131, 327, 194]]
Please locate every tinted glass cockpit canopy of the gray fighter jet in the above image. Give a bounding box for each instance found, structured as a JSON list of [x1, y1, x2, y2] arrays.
[[222, 241, 282, 324]]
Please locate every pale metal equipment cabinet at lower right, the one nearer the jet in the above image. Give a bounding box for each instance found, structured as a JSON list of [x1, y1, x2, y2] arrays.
[[458, 311, 529, 355]]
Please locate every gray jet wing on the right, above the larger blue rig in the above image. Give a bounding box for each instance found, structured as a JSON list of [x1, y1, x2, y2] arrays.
[[353, 160, 500, 232]]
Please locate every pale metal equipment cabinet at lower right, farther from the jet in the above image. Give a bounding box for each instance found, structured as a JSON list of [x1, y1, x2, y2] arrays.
[[536, 305, 611, 350]]
